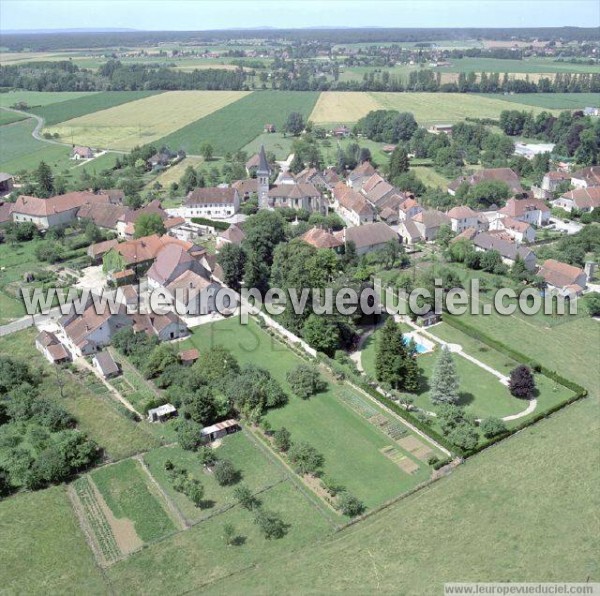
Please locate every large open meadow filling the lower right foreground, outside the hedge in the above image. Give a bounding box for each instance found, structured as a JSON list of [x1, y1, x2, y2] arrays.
[[207, 399, 600, 594]]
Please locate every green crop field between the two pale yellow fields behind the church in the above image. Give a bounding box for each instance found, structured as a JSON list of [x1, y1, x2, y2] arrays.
[[160, 91, 319, 155]]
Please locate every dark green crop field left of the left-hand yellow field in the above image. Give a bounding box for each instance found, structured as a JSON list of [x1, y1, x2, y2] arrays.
[[31, 91, 160, 126]]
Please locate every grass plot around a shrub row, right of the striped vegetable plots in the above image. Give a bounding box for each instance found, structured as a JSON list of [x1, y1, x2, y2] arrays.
[[144, 432, 284, 521]]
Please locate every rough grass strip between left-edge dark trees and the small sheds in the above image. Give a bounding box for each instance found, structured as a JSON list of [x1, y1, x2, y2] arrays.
[[0, 328, 160, 460]]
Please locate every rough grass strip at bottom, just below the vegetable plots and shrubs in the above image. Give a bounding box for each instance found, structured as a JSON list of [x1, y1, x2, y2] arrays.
[[107, 480, 331, 594]]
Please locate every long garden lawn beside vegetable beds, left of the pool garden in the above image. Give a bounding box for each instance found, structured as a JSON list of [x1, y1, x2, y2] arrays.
[[181, 318, 436, 508]]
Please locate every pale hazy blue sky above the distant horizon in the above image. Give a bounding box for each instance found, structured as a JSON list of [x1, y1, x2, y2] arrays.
[[0, 0, 600, 31]]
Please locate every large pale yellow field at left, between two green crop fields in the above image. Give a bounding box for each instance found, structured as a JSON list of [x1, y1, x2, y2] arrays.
[[48, 91, 250, 151]]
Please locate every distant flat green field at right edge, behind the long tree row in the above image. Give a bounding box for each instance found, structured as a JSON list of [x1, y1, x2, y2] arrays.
[[435, 58, 600, 73]]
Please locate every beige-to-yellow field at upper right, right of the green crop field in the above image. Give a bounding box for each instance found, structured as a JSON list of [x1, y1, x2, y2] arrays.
[[310, 91, 557, 124]]
